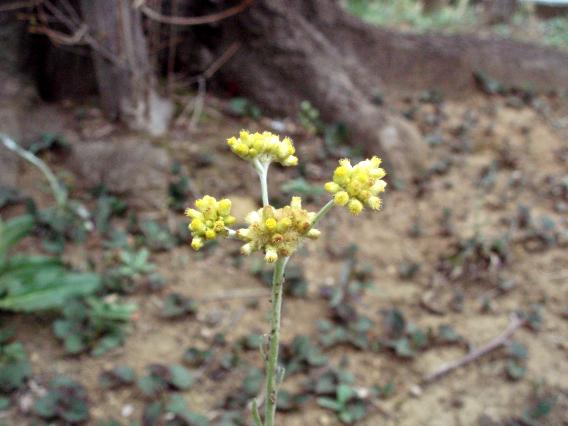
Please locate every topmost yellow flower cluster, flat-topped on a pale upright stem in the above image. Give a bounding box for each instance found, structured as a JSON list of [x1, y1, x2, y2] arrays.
[[227, 130, 298, 166]]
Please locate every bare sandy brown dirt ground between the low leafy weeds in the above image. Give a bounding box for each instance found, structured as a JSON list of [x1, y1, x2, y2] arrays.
[[0, 88, 568, 426]]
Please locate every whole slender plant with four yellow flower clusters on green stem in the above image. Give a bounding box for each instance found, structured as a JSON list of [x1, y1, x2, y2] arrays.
[[185, 130, 386, 426]]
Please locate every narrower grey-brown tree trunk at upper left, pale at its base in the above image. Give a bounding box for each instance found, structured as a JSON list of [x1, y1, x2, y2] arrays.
[[81, 0, 173, 135]]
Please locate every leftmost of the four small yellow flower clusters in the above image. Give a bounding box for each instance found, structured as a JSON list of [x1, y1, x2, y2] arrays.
[[185, 195, 235, 250]]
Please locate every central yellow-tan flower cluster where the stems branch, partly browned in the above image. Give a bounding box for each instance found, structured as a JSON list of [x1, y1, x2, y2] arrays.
[[237, 197, 320, 263]]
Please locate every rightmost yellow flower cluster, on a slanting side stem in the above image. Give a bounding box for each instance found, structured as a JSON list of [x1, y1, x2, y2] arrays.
[[325, 157, 387, 215]]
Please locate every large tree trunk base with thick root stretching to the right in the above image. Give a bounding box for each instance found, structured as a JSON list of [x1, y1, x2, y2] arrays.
[[223, 0, 568, 179]]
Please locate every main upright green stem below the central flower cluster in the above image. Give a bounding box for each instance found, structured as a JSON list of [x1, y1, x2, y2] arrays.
[[264, 258, 287, 426]]
